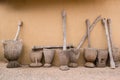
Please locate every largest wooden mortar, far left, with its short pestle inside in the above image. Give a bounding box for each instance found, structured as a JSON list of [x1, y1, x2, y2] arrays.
[[3, 21, 23, 68]]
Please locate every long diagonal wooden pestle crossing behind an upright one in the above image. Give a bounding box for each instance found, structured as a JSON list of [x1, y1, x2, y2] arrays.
[[77, 16, 102, 49]]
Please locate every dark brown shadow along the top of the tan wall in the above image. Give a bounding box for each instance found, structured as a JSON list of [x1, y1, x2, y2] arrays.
[[0, 0, 107, 10]]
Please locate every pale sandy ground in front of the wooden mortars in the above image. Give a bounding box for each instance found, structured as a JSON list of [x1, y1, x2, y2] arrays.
[[0, 63, 120, 80]]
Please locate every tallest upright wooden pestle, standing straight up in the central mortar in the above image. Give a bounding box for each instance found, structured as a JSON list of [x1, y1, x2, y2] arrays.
[[62, 10, 67, 50]]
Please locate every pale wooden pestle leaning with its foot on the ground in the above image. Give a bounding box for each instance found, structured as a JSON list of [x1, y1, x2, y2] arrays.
[[102, 18, 115, 69]]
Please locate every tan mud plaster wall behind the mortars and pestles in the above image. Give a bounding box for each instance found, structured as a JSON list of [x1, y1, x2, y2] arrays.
[[0, 0, 120, 65]]
